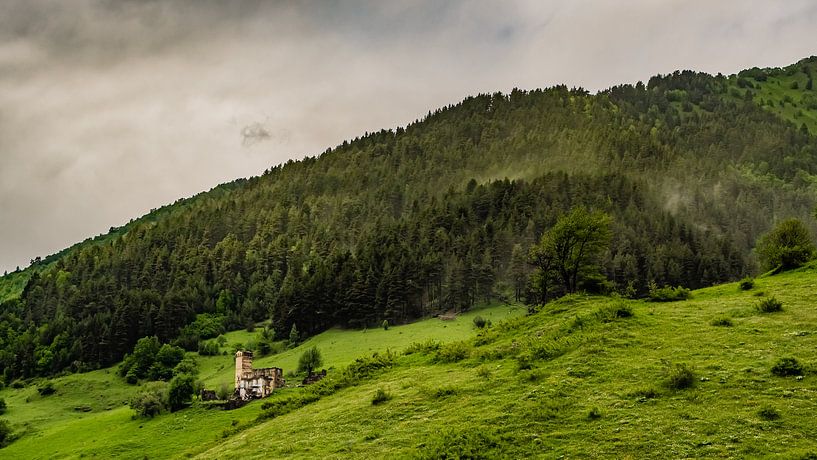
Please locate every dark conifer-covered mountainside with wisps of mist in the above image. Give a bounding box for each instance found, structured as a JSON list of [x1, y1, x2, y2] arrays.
[[0, 58, 817, 382]]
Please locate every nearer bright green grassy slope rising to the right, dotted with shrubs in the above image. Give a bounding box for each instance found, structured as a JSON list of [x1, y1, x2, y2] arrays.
[[201, 265, 817, 458]]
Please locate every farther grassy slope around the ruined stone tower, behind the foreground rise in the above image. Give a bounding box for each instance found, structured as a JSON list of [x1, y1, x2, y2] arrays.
[[0, 306, 524, 458]]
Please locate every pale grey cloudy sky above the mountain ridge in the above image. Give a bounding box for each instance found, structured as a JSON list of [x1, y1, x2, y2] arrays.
[[0, 0, 817, 273]]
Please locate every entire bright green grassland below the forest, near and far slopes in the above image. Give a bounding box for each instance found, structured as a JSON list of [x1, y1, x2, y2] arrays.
[[0, 264, 817, 459]]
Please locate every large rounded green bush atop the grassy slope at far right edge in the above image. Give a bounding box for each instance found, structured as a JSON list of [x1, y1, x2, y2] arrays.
[[755, 219, 815, 271]]
